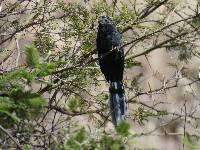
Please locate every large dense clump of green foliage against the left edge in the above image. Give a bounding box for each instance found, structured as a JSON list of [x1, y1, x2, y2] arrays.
[[0, 69, 46, 126]]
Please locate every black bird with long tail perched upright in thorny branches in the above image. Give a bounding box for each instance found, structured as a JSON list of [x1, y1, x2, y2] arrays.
[[96, 16, 127, 126]]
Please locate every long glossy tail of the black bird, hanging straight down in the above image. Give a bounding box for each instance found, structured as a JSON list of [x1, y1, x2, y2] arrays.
[[109, 81, 127, 126]]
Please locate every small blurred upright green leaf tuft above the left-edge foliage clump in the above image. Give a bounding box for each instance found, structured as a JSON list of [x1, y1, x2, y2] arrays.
[[25, 45, 40, 68]]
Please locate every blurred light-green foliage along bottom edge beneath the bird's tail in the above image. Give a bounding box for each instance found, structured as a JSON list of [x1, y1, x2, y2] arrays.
[[57, 123, 129, 150]]
